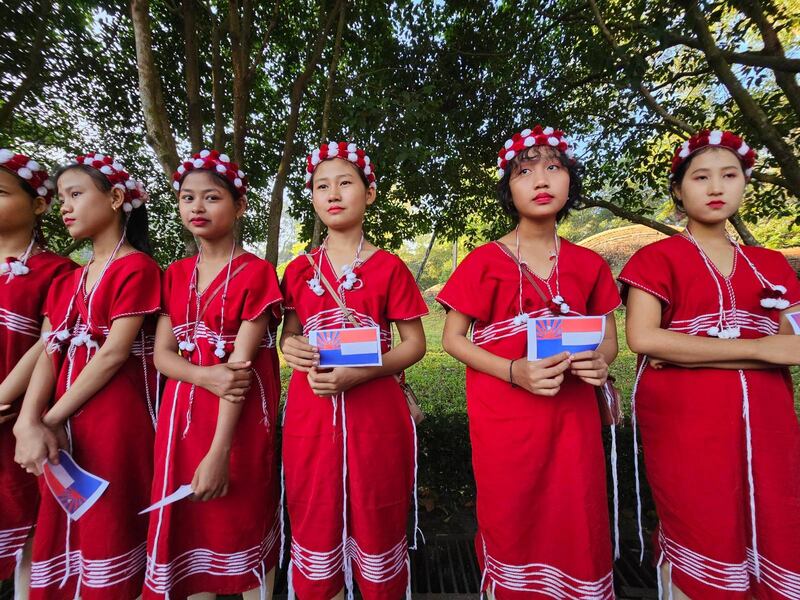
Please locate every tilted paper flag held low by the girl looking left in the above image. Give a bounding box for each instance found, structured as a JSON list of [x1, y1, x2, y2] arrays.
[[42, 450, 108, 521]]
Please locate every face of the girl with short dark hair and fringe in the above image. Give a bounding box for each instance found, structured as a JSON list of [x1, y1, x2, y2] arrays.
[[508, 149, 569, 219]]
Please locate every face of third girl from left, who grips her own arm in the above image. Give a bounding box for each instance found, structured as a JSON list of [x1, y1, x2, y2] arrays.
[[178, 170, 247, 240]]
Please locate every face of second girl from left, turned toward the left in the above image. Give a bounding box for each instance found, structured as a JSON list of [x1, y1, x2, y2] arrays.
[[57, 169, 125, 240]]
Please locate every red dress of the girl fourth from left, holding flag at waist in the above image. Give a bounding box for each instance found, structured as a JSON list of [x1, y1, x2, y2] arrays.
[[283, 248, 428, 600]]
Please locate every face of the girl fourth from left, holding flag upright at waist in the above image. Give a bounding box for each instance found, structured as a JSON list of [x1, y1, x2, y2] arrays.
[[311, 158, 375, 230]]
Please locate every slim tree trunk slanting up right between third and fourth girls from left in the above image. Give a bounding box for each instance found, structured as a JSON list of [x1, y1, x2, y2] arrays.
[[265, 0, 342, 264]]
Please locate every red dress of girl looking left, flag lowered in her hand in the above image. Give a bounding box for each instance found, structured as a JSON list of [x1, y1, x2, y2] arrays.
[[31, 252, 161, 600]]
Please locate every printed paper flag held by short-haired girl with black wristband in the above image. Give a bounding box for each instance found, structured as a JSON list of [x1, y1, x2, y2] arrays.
[[528, 317, 606, 360]]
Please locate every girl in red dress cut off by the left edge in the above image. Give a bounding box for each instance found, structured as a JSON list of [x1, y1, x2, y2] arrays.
[[0, 150, 77, 598]]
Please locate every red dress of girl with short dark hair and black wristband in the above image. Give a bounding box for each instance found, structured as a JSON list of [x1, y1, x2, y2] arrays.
[[437, 240, 620, 600]]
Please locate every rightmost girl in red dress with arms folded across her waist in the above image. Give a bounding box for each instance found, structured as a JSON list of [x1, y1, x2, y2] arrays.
[[620, 131, 800, 600]]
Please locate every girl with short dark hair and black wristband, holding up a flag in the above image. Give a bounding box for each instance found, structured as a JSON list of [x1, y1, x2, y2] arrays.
[[437, 125, 620, 599]]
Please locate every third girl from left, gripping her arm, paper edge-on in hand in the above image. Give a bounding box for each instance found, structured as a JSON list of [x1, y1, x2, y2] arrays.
[[144, 150, 282, 600]]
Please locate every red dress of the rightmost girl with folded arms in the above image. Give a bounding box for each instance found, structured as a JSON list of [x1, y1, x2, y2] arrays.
[[619, 235, 800, 600]]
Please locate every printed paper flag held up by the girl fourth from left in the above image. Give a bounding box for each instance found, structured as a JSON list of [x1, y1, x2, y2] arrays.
[[308, 327, 383, 367]]
